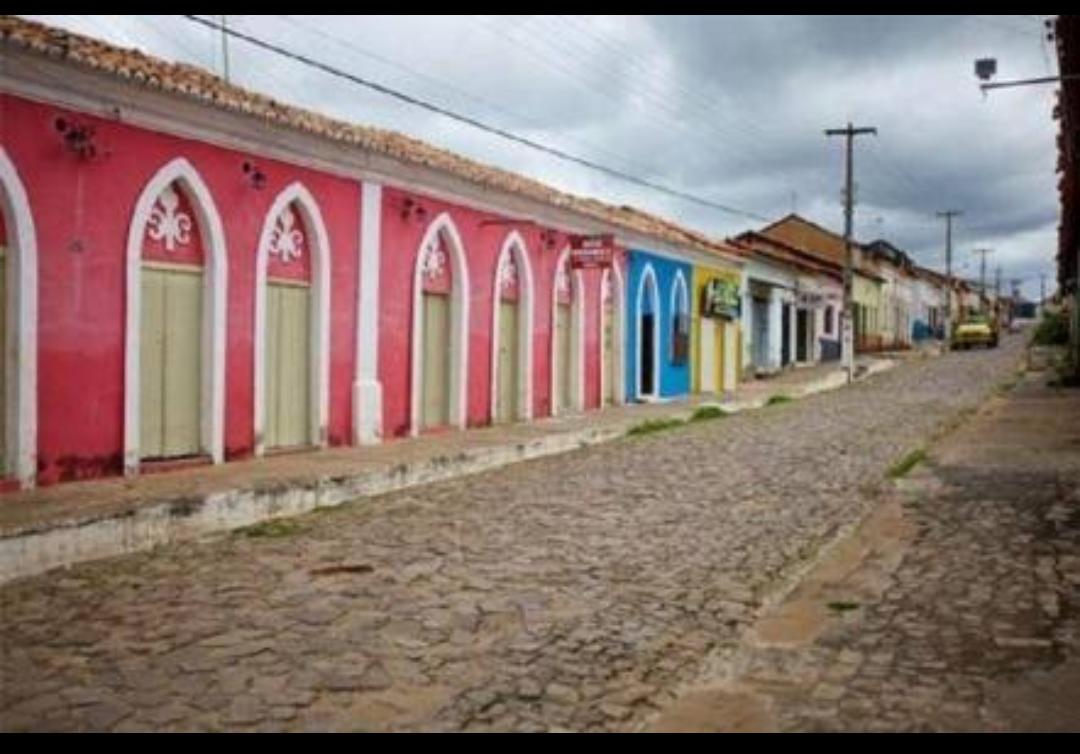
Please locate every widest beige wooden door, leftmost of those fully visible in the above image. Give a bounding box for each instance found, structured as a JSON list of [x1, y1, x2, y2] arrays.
[[139, 265, 203, 458]]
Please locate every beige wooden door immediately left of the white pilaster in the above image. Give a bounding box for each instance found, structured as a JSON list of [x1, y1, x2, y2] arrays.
[[264, 282, 311, 448]]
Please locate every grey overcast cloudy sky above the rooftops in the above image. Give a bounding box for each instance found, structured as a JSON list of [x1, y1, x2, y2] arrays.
[[28, 15, 1058, 296]]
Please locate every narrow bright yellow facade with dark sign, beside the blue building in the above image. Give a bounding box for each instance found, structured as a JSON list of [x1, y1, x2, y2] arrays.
[[690, 266, 742, 393]]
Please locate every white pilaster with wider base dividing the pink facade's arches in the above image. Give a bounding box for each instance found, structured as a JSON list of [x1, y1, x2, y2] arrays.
[[352, 181, 382, 445]]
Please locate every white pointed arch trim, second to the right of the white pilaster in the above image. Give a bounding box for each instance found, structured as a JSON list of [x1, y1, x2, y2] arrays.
[[490, 225, 536, 421]]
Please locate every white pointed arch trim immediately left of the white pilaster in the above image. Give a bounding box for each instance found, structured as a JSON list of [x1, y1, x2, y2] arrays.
[[253, 181, 330, 456]]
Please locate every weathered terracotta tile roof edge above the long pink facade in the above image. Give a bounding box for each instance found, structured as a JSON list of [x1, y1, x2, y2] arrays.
[[0, 15, 739, 264]]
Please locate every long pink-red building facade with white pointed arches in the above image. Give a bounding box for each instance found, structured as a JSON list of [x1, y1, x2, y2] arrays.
[[0, 19, 673, 489]]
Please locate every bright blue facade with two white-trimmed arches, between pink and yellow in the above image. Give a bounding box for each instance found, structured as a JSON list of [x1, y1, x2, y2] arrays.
[[623, 250, 693, 401]]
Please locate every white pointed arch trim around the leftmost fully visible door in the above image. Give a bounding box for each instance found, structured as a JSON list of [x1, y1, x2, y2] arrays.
[[124, 158, 228, 474]]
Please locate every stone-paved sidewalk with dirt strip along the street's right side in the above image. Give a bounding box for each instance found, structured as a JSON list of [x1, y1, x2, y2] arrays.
[[657, 347, 1080, 732]]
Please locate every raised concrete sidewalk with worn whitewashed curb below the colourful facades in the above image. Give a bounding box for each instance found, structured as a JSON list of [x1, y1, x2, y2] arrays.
[[0, 359, 895, 582]]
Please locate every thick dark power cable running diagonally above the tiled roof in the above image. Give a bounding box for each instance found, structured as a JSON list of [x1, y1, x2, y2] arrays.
[[184, 14, 769, 223]]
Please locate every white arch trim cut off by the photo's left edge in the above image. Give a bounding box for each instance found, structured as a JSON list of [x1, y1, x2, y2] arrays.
[[0, 146, 38, 488]]
